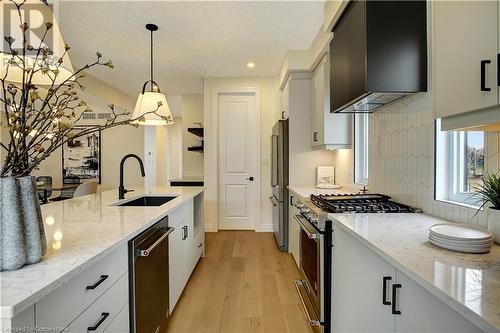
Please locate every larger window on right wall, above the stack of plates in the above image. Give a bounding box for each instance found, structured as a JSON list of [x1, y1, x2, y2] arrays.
[[436, 120, 484, 206]]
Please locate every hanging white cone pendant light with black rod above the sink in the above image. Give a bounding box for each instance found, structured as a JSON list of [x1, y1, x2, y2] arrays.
[[132, 23, 174, 126]]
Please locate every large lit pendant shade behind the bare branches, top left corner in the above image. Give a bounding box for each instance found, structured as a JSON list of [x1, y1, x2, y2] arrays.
[[0, 0, 73, 86]]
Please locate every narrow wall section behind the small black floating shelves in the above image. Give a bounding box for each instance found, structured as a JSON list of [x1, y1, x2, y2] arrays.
[[182, 94, 204, 178]]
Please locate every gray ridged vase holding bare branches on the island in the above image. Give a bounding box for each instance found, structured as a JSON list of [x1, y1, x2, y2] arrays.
[[0, 176, 47, 271]]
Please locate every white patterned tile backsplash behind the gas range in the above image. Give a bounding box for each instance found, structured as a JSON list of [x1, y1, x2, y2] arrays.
[[368, 93, 500, 226]]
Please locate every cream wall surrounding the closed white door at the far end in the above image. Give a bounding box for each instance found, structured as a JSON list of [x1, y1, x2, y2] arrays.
[[203, 77, 279, 231]]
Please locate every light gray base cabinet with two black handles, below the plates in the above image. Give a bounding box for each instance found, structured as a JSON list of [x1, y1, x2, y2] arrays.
[[332, 224, 482, 333]]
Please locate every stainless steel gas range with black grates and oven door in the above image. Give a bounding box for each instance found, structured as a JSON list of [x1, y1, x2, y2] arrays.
[[291, 194, 421, 333]]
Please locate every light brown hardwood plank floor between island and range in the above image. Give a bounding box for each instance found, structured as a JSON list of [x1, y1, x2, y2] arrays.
[[168, 231, 312, 333]]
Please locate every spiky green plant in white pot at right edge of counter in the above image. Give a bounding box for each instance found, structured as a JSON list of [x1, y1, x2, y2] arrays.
[[476, 172, 500, 244]]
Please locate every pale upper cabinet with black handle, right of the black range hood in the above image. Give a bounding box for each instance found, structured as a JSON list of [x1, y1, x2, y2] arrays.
[[432, 1, 500, 121]]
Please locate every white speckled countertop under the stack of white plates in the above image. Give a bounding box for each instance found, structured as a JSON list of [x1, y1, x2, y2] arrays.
[[329, 214, 500, 332]]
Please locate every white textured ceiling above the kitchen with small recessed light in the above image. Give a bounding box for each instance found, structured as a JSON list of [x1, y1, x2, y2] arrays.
[[58, 0, 324, 96]]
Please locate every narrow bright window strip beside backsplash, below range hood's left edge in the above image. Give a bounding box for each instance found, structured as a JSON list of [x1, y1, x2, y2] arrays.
[[354, 113, 369, 185]]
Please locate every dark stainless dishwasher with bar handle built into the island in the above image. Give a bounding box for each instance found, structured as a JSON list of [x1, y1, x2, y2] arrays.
[[129, 217, 173, 333]]
